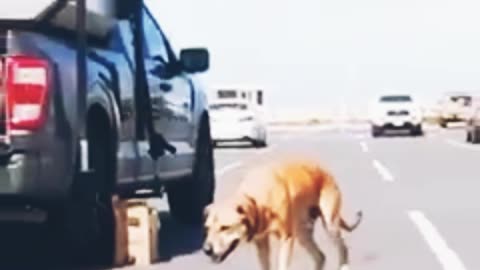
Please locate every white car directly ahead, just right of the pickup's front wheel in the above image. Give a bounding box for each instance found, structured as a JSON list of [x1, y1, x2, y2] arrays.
[[209, 100, 267, 147]]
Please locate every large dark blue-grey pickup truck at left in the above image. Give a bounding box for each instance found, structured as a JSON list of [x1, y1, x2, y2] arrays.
[[0, 1, 215, 262]]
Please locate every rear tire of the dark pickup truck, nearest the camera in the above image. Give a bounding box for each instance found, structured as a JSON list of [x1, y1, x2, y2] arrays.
[[50, 113, 115, 266]]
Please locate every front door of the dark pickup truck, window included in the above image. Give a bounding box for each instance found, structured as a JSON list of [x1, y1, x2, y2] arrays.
[[143, 8, 194, 177]]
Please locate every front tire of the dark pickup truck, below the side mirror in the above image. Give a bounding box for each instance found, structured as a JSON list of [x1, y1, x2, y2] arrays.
[[166, 117, 215, 225]]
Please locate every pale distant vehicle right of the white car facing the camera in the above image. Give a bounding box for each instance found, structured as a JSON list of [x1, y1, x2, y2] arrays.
[[439, 92, 472, 128]]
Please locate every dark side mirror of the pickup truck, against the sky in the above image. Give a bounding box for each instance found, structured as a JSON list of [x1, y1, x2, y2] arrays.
[[180, 48, 210, 73]]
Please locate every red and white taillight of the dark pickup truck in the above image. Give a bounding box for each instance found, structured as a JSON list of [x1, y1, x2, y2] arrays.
[[4, 55, 49, 130]]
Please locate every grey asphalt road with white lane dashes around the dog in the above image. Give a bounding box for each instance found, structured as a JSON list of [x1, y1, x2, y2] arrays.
[[145, 124, 480, 270]]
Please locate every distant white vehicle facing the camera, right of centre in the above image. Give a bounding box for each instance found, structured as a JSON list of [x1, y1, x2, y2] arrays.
[[370, 94, 423, 137]]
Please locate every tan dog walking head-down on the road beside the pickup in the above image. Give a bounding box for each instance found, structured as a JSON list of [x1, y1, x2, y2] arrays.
[[202, 159, 363, 270]]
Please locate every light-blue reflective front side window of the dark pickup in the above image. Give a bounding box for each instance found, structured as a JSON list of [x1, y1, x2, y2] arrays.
[[143, 9, 170, 63]]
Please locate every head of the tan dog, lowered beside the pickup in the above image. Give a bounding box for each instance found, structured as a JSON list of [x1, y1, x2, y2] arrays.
[[203, 196, 256, 263]]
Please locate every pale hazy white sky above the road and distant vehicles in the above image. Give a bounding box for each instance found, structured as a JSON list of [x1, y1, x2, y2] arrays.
[[147, 0, 480, 117]]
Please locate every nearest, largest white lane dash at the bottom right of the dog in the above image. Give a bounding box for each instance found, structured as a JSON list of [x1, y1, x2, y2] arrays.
[[408, 210, 466, 270]]
